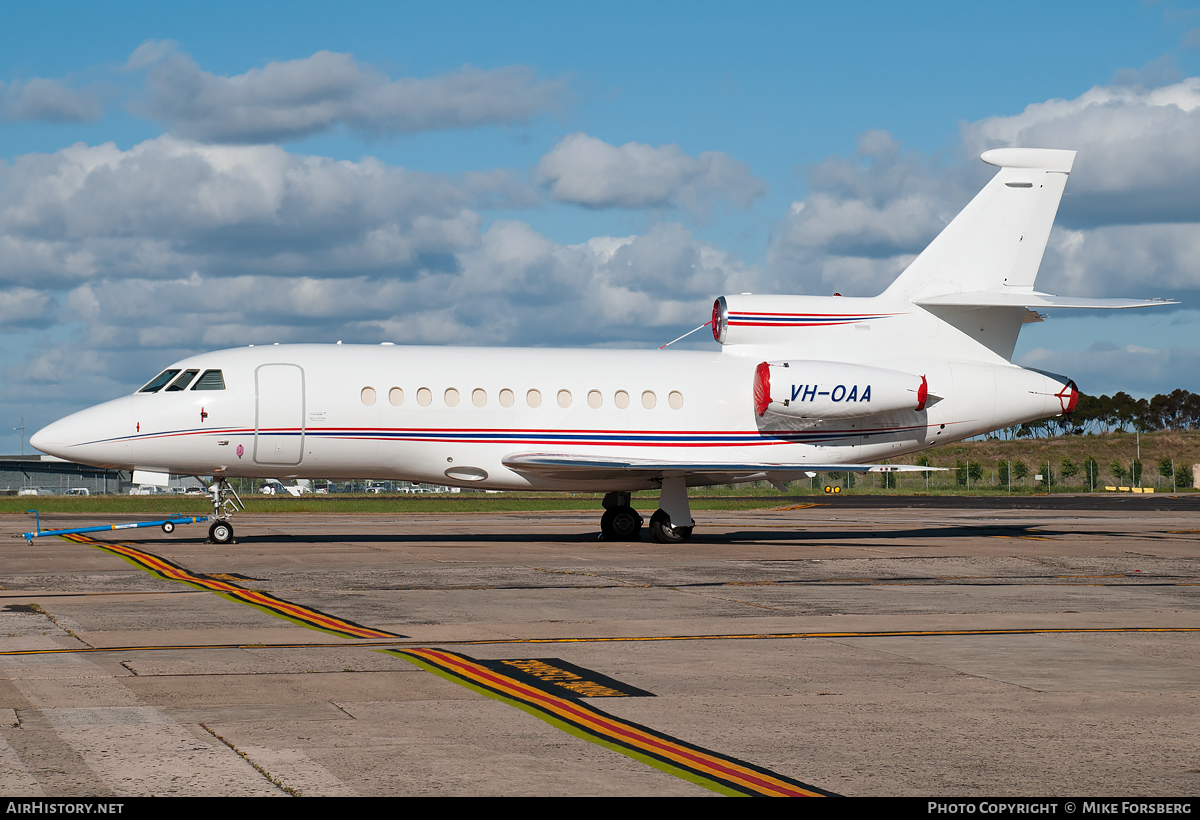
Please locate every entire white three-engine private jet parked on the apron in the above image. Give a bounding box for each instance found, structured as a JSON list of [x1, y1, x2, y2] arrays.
[[31, 148, 1168, 543]]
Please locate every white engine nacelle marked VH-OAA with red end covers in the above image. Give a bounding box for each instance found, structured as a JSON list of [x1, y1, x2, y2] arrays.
[[754, 361, 929, 420]]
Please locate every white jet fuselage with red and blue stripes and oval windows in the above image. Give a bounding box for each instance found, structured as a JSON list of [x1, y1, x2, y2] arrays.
[[34, 345, 1064, 491]]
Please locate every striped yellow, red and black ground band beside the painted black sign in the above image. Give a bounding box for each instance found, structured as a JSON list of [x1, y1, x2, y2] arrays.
[[385, 648, 833, 797]]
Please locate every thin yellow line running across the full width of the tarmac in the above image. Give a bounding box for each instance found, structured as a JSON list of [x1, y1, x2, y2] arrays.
[[0, 627, 1200, 657]]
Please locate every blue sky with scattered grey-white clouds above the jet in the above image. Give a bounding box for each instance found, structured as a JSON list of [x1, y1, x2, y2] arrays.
[[0, 0, 1200, 453]]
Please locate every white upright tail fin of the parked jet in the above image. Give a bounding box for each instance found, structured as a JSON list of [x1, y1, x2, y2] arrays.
[[884, 148, 1075, 301]]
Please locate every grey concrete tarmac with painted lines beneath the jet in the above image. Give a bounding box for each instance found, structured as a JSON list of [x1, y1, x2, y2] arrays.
[[0, 496, 1200, 797]]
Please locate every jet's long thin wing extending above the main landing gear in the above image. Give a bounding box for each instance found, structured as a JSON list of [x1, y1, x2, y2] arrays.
[[502, 453, 947, 484]]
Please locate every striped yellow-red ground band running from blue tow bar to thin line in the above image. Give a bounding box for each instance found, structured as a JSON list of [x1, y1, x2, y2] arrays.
[[61, 534, 404, 638]]
